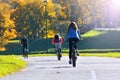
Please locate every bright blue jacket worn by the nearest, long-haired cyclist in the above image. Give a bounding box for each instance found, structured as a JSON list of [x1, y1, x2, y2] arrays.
[[66, 28, 81, 40]]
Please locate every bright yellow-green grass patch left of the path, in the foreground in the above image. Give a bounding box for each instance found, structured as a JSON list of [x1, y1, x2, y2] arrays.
[[0, 55, 27, 77]]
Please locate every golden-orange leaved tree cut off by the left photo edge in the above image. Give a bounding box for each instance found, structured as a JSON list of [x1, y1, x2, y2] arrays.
[[0, 2, 16, 51]]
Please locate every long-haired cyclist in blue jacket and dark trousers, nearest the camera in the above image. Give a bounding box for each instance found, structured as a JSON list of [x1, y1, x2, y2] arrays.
[[66, 22, 81, 64]]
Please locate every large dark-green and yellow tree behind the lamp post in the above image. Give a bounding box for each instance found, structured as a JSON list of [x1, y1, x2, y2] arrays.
[[12, 0, 56, 38]]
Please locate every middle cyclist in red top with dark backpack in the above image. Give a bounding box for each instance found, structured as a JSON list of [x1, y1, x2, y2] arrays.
[[52, 34, 62, 57]]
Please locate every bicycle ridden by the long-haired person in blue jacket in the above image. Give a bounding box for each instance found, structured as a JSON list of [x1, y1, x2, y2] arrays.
[[71, 41, 77, 67]]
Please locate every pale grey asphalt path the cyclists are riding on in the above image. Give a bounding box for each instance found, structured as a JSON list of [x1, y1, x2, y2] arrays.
[[0, 56, 120, 80]]
